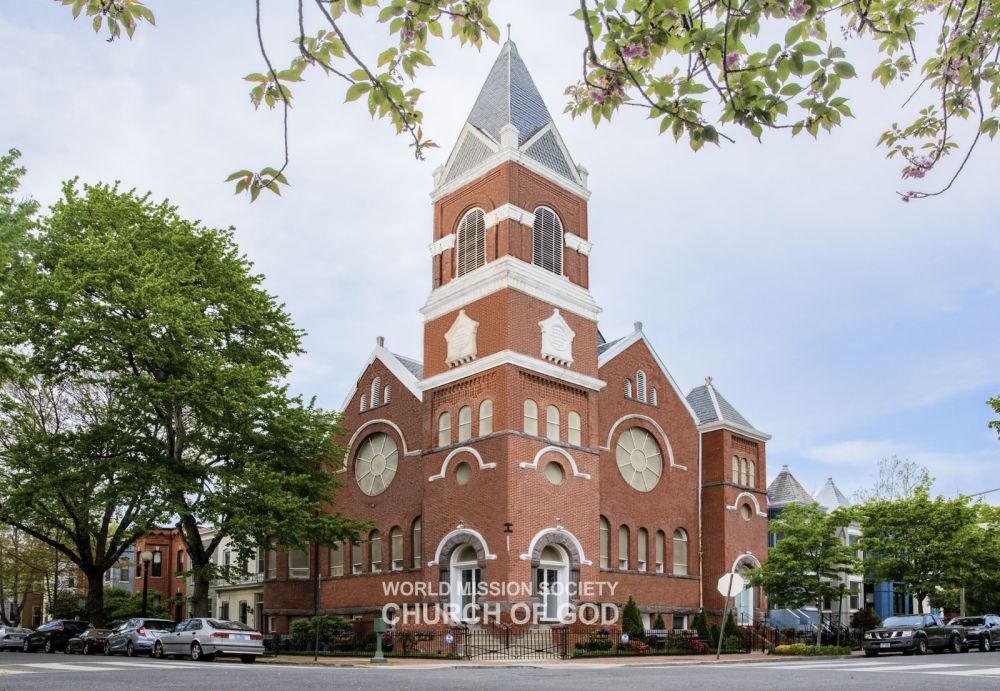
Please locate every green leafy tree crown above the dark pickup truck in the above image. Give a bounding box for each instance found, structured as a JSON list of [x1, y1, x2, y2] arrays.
[[852, 487, 982, 606]]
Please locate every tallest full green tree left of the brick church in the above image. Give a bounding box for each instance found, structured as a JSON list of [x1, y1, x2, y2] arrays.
[[0, 181, 368, 616]]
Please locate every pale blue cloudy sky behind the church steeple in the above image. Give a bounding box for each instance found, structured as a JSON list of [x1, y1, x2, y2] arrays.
[[0, 0, 1000, 502]]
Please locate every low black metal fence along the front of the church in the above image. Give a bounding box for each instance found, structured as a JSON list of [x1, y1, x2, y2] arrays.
[[264, 622, 790, 660]]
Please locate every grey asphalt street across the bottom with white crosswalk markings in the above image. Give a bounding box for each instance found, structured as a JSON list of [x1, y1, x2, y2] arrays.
[[0, 653, 1000, 691]]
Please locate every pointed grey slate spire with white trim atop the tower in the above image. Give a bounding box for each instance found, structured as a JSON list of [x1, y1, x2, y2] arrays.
[[434, 40, 587, 197]]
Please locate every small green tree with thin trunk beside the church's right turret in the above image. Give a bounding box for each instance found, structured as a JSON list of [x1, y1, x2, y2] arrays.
[[750, 504, 858, 645]]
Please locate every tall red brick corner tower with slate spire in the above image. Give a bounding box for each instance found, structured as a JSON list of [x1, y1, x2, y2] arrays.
[[420, 40, 604, 620]]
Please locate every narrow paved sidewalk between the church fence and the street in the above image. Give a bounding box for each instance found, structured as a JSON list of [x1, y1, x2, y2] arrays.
[[248, 651, 860, 669]]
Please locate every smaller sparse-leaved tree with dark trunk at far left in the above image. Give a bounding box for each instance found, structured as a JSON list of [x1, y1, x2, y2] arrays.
[[0, 378, 167, 625]]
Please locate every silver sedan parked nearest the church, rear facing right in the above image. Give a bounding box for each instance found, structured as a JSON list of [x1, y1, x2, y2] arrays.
[[153, 617, 264, 663]]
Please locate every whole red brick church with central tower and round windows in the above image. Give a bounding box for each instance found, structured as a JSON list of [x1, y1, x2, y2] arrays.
[[264, 41, 769, 632]]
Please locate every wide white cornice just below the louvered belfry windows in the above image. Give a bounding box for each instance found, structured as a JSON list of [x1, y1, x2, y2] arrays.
[[420, 255, 600, 324]]
